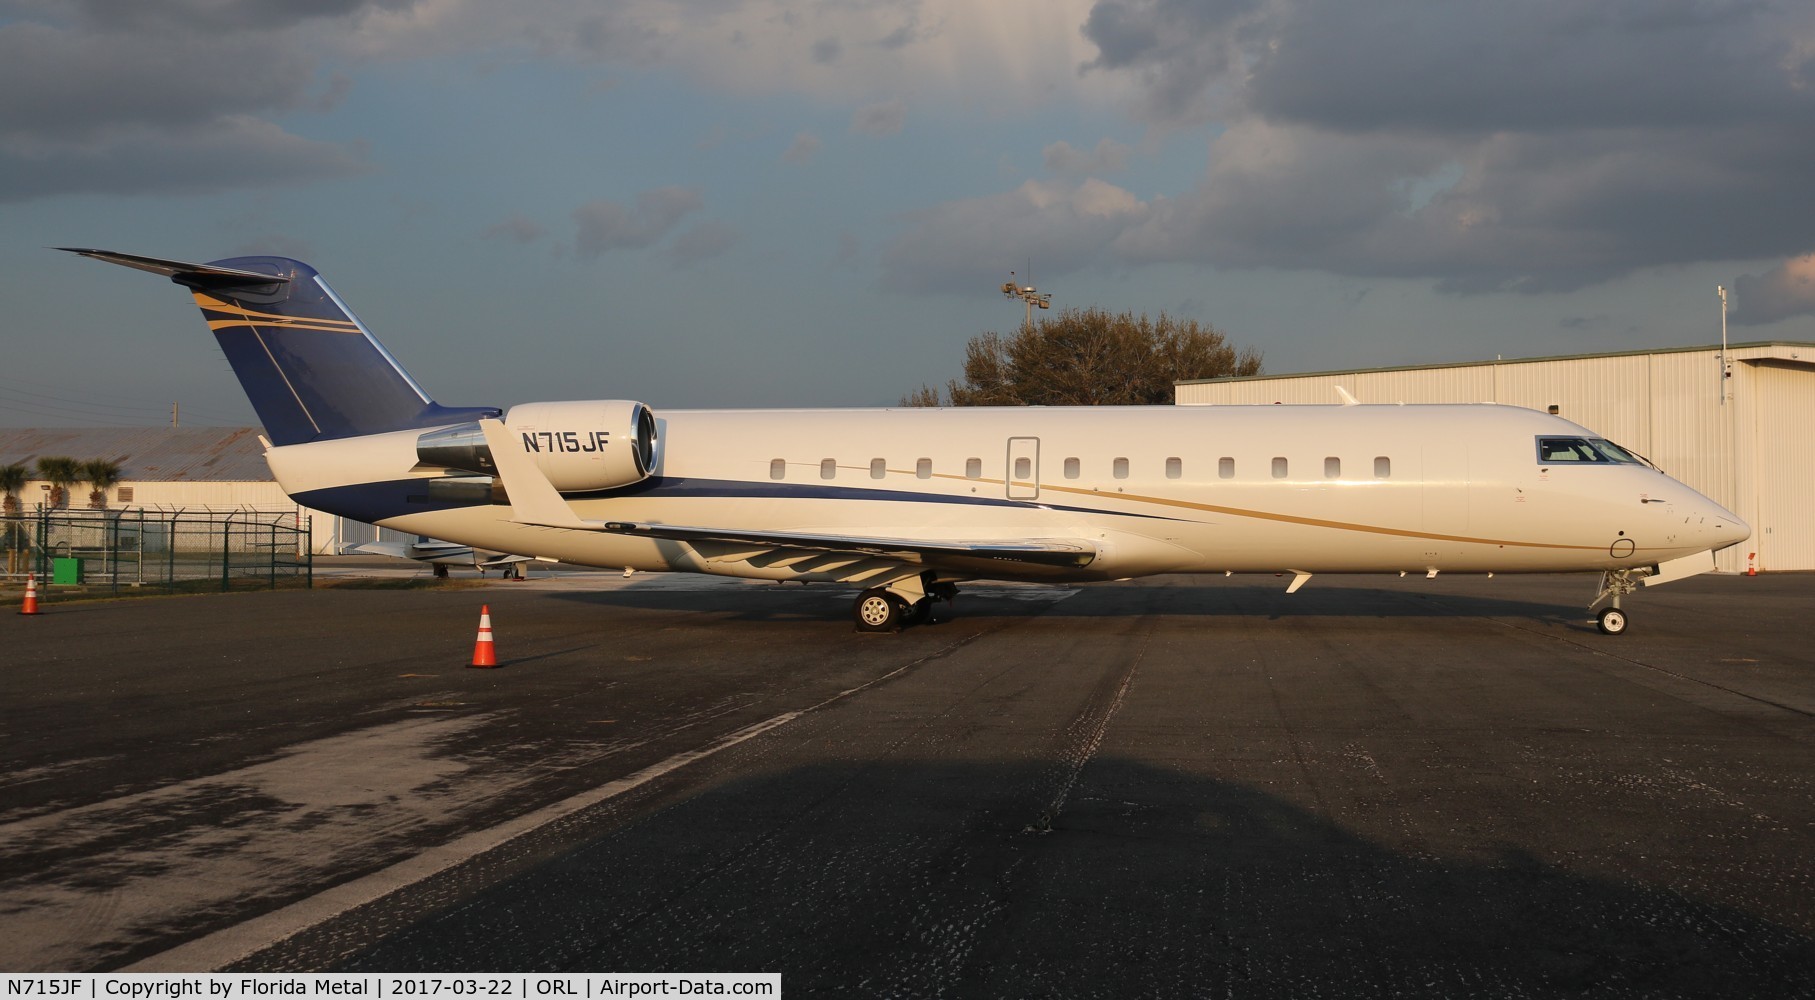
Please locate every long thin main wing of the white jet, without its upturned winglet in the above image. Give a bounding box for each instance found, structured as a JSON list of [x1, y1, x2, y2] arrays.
[[595, 521, 1096, 568]]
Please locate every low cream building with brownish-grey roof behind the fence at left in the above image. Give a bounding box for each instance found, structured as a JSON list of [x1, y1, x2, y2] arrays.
[[0, 426, 399, 555]]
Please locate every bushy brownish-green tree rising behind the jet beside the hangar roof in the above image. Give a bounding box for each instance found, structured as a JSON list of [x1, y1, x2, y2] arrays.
[[902, 309, 1261, 407]]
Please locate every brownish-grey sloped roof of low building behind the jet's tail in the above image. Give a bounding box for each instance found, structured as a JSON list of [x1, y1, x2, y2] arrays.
[[0, 426, 272, 483]]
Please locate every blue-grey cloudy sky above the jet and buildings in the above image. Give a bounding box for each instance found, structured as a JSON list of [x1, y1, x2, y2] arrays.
[[0, 0, 1815, 425]]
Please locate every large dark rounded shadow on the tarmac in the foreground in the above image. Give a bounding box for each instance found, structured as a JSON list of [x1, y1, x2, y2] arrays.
[[243, 757, 1815, 998]]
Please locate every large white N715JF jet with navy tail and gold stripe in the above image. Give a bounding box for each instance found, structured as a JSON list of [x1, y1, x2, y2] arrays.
[[67, 254, 1750, 633]]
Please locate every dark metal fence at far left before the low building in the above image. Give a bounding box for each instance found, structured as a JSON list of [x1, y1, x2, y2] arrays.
[[0, 508, 314, 593]]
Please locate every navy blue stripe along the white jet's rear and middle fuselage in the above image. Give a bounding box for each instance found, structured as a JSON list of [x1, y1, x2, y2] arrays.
[[290, 477, 1183, 523]]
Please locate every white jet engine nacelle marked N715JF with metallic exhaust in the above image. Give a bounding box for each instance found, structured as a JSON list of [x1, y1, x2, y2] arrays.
[[416, 399, 661, 492]]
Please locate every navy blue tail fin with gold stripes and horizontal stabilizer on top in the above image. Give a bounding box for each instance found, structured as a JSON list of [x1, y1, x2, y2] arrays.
[[58, 247, 499, 445]]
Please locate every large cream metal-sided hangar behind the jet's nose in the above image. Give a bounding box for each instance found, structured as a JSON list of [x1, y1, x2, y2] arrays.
[[1174, 341, 1815, 572]]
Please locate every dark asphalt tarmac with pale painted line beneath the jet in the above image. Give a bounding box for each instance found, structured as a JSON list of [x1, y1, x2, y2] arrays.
[[0, 574, 1815, 998]]
